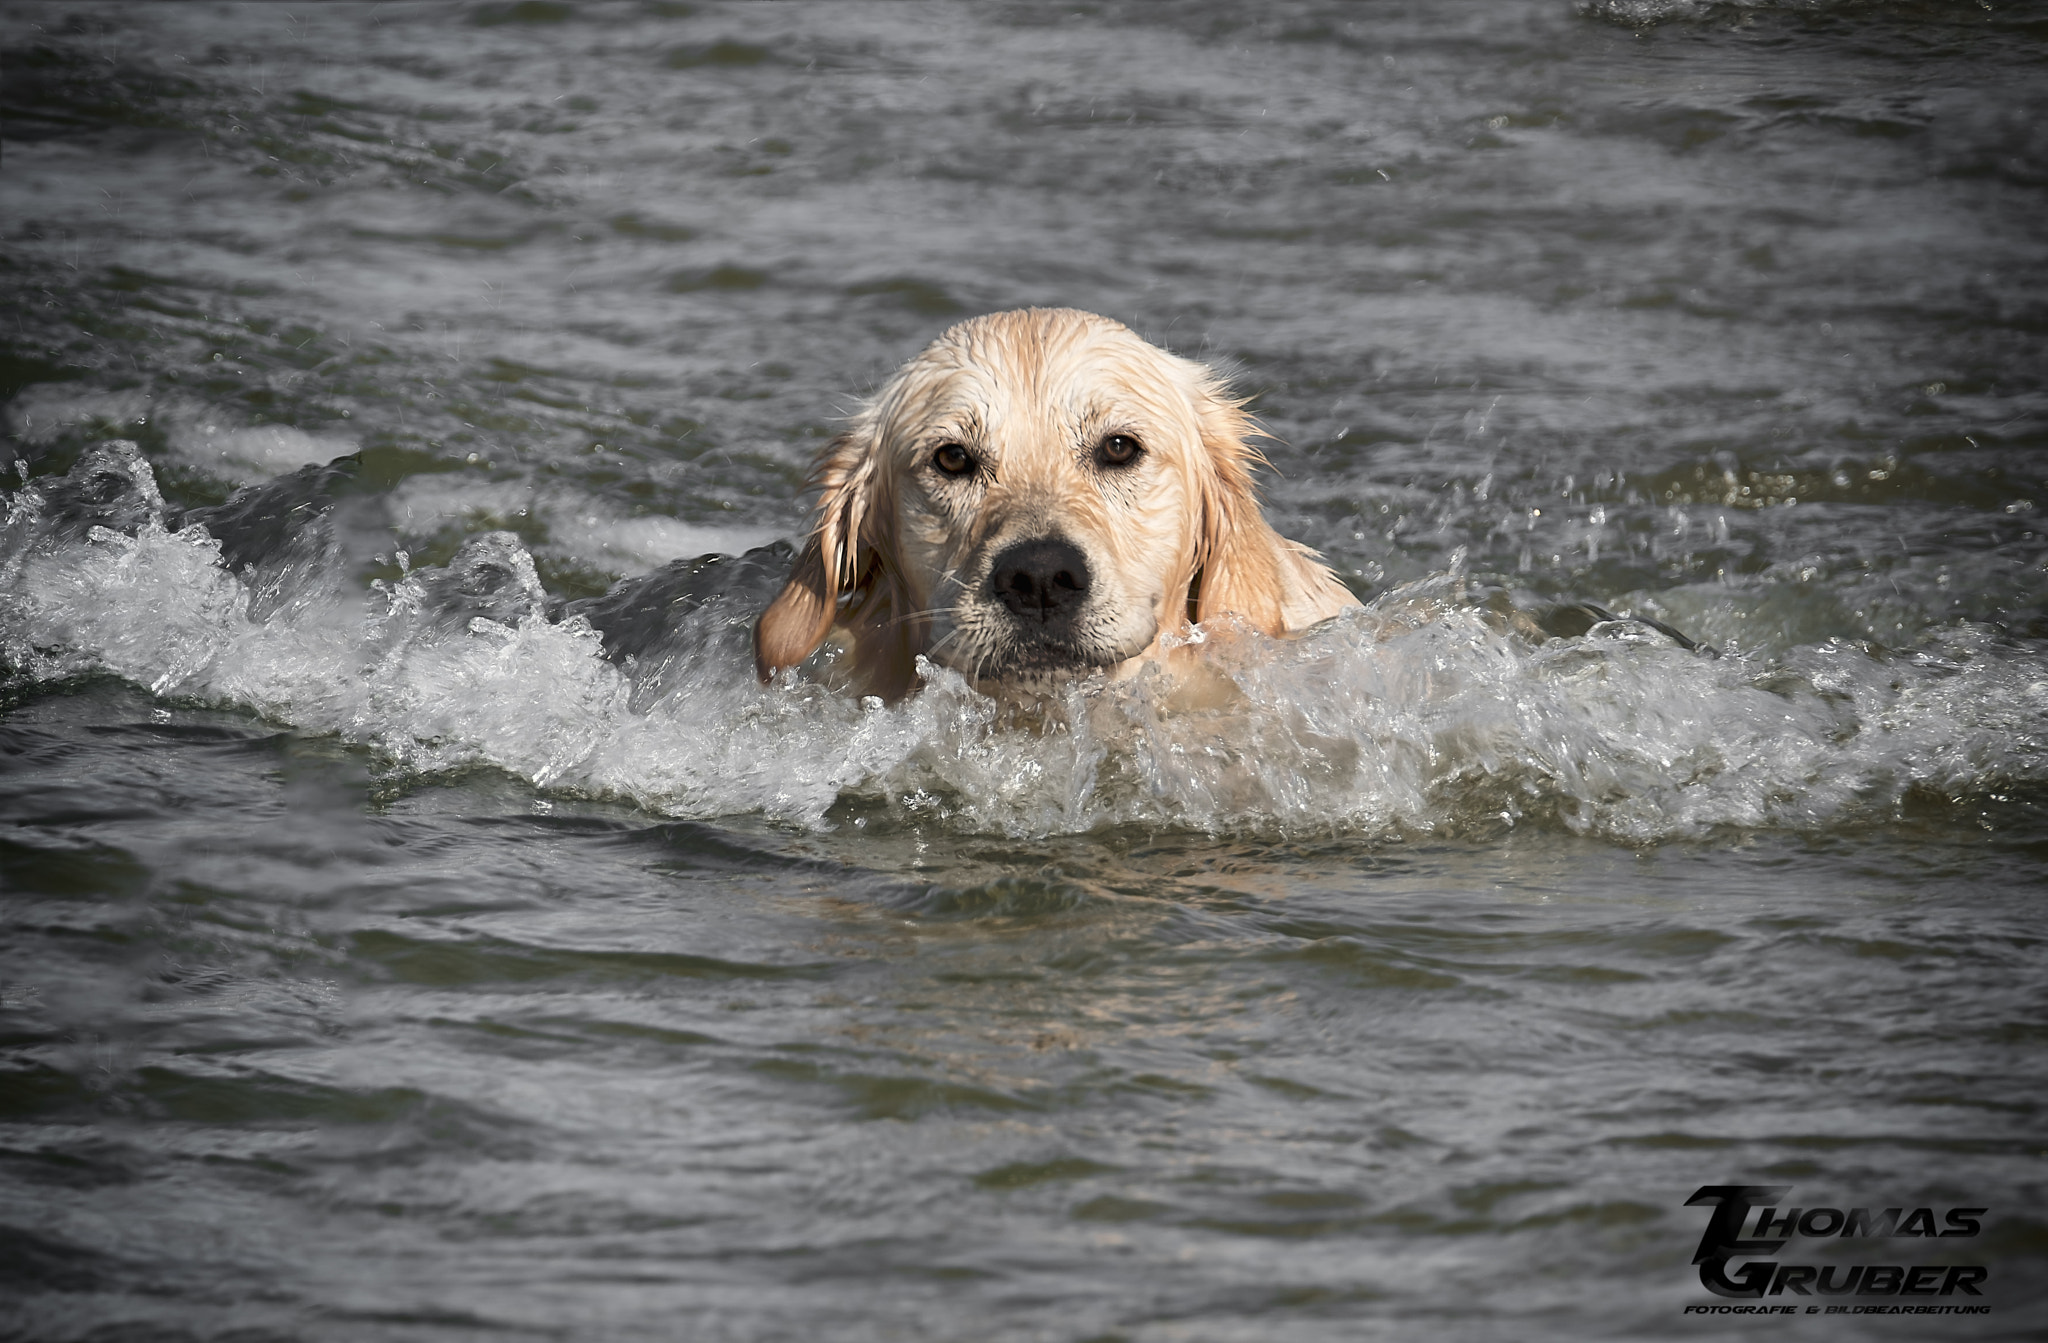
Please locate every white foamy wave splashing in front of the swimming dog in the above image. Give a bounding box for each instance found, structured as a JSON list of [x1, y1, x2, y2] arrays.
[[0, 442, 2048, 841]]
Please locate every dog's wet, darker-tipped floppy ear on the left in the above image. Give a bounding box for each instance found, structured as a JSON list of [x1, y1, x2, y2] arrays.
[[754, 424, 881, 682]]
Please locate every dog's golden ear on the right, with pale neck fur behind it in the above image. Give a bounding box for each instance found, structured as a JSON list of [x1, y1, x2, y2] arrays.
[[1188, 377, 1358, 635]]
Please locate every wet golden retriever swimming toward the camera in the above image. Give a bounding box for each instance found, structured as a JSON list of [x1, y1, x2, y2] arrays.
[[754, 307, 1358, 700]]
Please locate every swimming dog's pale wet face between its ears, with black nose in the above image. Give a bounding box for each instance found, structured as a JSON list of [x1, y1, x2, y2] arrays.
[[877, 321, 1204, 678]]
